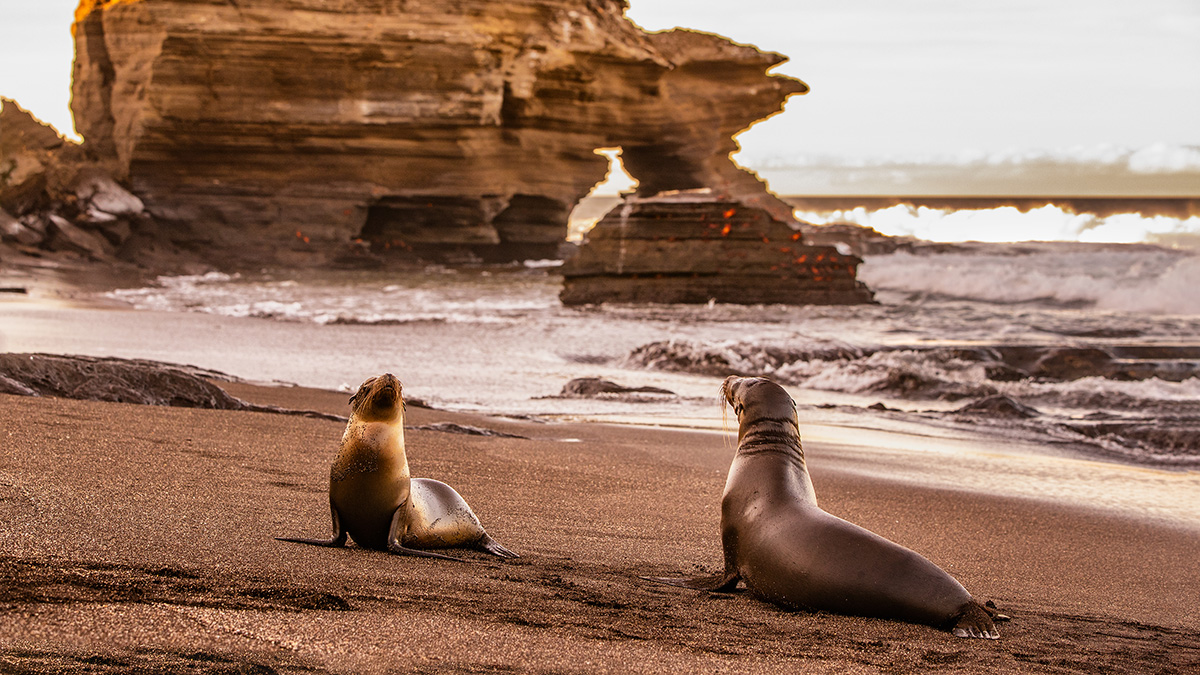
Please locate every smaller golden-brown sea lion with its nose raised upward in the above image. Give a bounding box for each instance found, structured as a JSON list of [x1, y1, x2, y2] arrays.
[[276, 372, 518, 560]]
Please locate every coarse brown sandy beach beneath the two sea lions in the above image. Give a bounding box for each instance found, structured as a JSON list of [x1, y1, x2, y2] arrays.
[[0, 383, 1200, 673]]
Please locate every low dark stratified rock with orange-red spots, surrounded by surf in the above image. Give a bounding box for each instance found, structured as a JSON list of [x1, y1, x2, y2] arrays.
[[559, 193, 872, 305]]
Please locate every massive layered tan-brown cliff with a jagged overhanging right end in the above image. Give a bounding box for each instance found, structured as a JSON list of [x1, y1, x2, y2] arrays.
[[72, 0, 806, 261]]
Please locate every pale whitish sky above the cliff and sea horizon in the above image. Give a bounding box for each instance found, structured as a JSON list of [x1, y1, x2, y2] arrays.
[[0, 0, 1200, 183]]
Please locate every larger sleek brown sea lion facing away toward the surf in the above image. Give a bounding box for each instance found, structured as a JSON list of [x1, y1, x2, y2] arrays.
[[647, 377, 1006, 639]]
